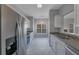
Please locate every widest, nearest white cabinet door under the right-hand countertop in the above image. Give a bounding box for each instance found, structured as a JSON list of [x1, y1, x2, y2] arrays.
[[56, 40, 65, 55]]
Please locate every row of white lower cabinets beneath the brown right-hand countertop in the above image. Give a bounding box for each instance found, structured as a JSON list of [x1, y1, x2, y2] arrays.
[[50, 35, 66, 55]]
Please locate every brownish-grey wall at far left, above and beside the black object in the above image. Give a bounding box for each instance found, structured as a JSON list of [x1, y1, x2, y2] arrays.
[[1, 5, 18, 54]]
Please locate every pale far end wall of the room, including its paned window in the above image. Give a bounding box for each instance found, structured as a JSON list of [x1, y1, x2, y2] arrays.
[[34, 18, 49, 38]]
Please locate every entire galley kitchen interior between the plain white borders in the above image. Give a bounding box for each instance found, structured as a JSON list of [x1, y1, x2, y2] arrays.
[[1, 4, 79, 55]]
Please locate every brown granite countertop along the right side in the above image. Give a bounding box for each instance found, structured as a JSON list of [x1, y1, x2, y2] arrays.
[[51, 32, 79, 54]]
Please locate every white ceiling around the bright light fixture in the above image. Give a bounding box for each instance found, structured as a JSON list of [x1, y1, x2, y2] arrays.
[[12, 4, 62, 18]]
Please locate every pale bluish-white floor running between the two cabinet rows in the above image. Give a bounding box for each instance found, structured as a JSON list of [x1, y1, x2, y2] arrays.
[[27, 38, 54, 55]]
